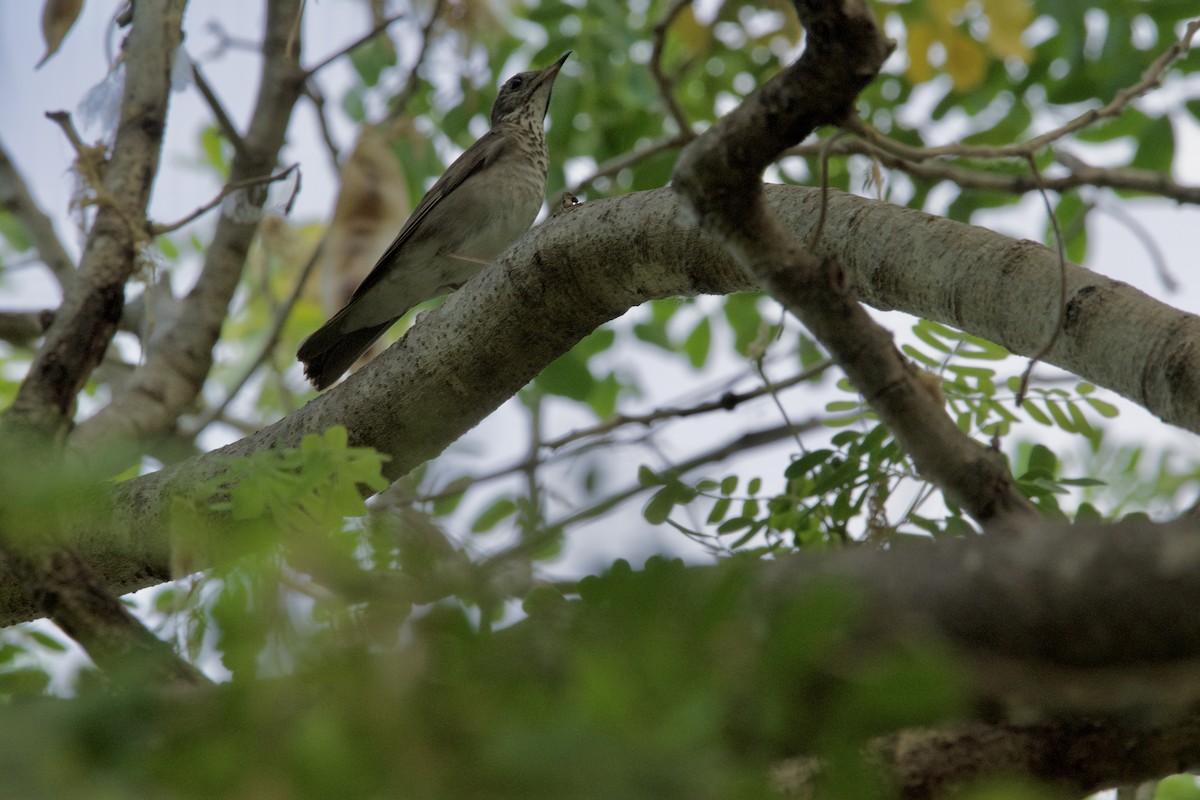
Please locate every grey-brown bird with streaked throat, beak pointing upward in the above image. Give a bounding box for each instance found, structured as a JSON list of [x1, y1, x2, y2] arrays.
[[296, 52, 570, 391]]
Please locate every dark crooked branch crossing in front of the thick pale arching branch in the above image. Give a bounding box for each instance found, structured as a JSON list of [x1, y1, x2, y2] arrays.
[[674, 0, 1037, 524]]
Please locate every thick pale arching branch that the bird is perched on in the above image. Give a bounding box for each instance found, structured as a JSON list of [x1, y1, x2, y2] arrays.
[[0, 186, 1200, 624]]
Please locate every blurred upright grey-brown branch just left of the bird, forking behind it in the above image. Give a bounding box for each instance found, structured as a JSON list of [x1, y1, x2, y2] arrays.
[[68, 0, 305, 453]]
